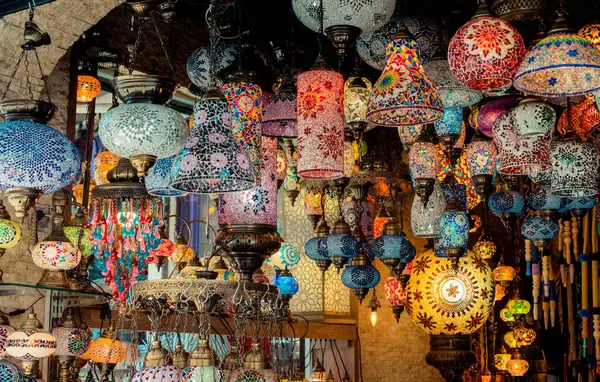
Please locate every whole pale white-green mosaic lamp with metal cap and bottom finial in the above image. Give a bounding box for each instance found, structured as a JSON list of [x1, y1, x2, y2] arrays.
[[98, 75, 190, 178]]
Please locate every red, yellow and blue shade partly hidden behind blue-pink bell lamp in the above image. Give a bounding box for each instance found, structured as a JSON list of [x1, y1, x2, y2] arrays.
[[220, 82, 263, 179]]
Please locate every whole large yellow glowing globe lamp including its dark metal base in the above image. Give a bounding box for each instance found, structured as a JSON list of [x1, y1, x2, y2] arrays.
[[405, 249, 494, 380]]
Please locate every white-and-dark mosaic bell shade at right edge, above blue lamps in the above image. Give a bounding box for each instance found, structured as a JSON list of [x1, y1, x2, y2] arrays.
[[551, 138, 599, 197]]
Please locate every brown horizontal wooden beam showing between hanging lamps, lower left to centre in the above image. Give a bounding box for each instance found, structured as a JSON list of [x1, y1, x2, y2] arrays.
[[80, 308, 357, 341]]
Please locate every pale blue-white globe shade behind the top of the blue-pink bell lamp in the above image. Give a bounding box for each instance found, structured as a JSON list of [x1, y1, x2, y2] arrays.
[[187, 40, 238, 91]]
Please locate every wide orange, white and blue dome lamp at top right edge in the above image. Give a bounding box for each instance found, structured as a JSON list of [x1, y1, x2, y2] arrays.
[[514, 14, 600, 97]]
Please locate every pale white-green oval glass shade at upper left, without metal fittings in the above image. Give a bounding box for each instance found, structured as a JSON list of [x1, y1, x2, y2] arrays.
[[98, 103, 190, 158]]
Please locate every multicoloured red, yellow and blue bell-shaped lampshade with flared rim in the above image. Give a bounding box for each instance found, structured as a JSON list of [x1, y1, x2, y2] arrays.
[[367, 29, 444, 126]]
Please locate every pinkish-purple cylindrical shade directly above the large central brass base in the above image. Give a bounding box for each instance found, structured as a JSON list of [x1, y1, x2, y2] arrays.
[[219, 137, 277, 226]]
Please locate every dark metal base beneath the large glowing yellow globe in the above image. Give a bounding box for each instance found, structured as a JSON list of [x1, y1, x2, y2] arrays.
[[425, 334, 477, 382]]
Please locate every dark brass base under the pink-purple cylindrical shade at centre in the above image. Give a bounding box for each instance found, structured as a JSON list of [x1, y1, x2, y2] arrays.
[[215, 224, 282, 281]]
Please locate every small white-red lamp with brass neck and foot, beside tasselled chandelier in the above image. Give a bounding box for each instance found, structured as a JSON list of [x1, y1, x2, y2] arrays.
[[31, 191, 81, 289]]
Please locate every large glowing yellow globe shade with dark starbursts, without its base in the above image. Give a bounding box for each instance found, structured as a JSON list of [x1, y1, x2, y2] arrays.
[[406, 249, 494, 335]]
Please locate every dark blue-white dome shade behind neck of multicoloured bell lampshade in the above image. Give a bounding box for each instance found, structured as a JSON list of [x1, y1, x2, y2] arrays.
[[356, 14, 449, 70]]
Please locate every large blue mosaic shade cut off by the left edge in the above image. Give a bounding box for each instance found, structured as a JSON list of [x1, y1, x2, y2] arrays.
[[0, 120, 81, 194]]
